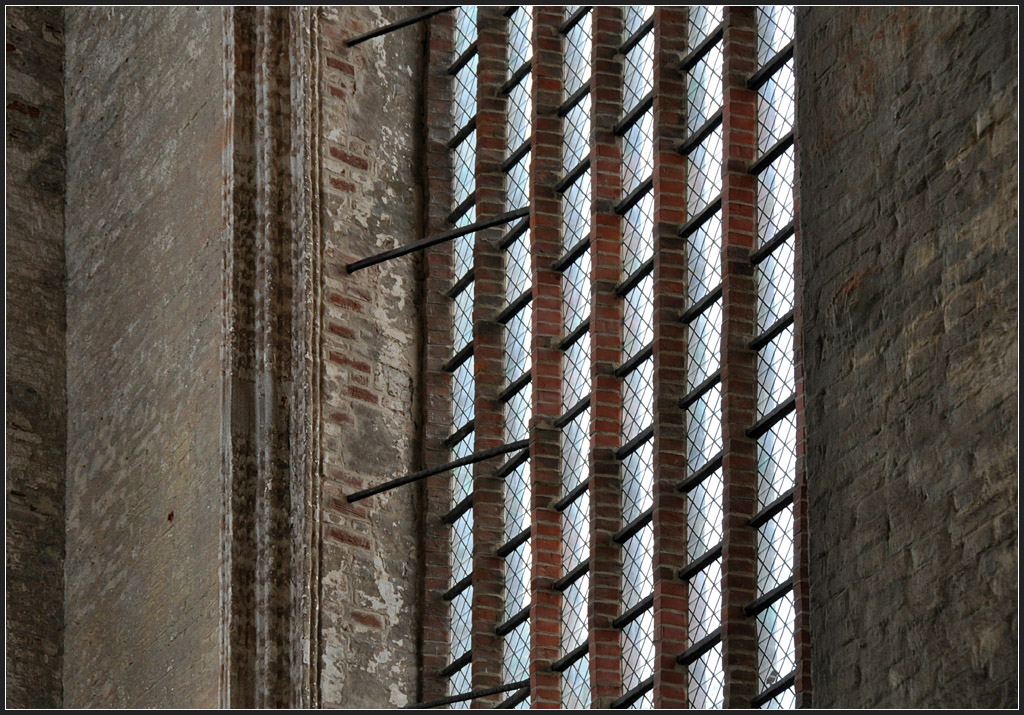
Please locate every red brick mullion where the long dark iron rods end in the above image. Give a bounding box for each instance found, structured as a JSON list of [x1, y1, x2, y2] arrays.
[[529, 6, 562, 708]]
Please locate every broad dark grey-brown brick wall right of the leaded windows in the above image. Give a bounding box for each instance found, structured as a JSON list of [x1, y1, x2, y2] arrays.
[[797, 8, 1018, 708]]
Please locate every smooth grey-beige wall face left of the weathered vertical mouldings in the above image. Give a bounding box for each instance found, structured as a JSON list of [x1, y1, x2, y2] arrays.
[[63, 8, 225, 707]]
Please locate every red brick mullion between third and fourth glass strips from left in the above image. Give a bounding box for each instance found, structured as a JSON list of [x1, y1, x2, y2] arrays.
[[588, 5, 623, 708]]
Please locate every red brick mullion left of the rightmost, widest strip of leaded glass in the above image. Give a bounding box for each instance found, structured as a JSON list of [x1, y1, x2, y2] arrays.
[[722, 6, 758, 708]]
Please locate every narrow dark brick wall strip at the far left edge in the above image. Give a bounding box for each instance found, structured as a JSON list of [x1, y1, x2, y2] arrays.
[[4, 7, 67, 708]]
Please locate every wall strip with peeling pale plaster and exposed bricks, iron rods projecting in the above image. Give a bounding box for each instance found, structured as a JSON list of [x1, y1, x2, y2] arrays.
[[319, 7, 419, 708]]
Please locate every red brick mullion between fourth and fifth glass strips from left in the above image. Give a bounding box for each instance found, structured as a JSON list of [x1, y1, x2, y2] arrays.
[[651, 6, 687, 708]]
